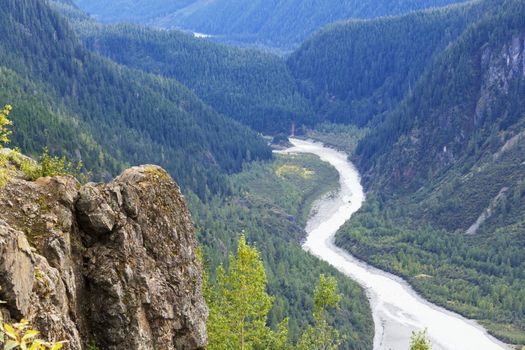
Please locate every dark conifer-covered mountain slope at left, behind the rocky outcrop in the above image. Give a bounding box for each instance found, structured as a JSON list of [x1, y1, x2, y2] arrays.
[[0, 0, 271, 197]]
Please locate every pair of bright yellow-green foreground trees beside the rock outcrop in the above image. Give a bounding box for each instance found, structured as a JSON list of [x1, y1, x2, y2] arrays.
[[204, 235, 354, 350]]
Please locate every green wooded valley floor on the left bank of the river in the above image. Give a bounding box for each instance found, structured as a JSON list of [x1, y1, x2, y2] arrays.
[[192, 155, 373, 350]]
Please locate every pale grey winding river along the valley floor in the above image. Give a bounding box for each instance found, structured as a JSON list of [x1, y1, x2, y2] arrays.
[[281, 139, 508, 350]]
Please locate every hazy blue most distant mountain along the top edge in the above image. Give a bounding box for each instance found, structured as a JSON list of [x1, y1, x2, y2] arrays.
[[71, 0, 464, 50]]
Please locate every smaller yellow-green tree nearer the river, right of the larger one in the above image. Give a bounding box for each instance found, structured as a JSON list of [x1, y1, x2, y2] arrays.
[[297, 274, 345, 350]]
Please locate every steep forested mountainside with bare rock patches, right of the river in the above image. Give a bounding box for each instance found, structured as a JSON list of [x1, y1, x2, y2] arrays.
[[337, 0, 525, 344]]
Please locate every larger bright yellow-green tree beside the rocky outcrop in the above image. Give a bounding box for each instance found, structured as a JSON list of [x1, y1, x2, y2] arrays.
[[205, 235, 288, 350]]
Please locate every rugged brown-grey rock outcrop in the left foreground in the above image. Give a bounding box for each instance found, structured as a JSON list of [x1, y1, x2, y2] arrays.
[[0, 166, 207, 350]]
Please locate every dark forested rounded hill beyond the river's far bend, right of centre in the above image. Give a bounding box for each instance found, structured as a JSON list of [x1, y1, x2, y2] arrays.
[[288, 2, 486, 126]]
